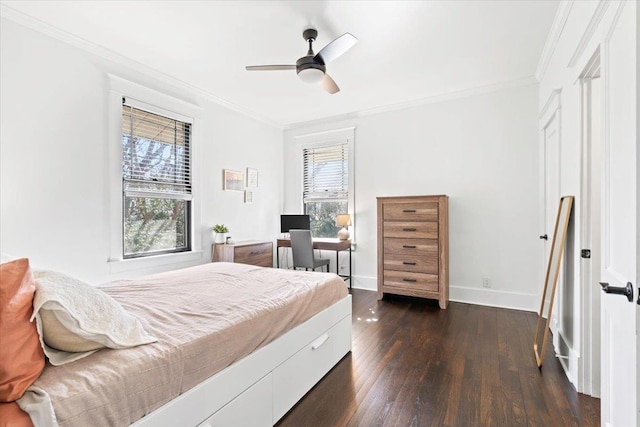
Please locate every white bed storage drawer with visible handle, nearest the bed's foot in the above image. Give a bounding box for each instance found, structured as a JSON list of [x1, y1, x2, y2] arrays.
[[273, 316, 351, 424]]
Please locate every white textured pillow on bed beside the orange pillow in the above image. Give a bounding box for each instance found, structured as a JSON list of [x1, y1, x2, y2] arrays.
[[31, 270, 157, 366]]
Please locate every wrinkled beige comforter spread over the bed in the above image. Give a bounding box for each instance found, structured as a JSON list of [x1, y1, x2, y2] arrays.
[[25, 263, 347, 427]]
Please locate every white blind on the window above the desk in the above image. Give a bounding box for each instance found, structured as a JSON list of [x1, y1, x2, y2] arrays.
[[303, 142, 349, 203]]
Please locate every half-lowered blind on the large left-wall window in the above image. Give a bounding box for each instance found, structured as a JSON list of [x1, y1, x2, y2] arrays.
[[122, 100, 191, 200]]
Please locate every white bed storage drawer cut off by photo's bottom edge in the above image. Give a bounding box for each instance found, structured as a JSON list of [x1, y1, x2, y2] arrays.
[[200, 373, 273, 427]]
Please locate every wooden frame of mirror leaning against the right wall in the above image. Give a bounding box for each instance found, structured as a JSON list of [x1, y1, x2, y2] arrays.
[[533, 196, 573, 368]]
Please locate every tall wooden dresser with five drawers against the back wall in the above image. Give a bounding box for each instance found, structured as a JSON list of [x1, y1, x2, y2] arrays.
[[378, 195, 449, 309]]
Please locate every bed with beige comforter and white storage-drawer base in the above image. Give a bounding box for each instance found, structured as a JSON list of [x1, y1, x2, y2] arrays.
[[12, 263, 351, 427]]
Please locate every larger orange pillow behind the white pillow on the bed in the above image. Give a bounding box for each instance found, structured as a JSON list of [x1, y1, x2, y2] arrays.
[[0, 258, 44, 402]]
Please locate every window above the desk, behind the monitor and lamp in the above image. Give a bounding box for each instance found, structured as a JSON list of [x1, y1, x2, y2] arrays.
[[302, 142, 349, 237]]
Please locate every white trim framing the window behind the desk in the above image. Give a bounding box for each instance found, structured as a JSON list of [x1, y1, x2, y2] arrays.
[[295, 127, 356, 245]]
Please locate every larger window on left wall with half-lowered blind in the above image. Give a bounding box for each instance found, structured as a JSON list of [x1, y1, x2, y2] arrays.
[[121, 102, 192, 258]]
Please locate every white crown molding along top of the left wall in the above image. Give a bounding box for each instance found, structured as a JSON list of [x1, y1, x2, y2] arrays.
[[0, 3, 284, 130]]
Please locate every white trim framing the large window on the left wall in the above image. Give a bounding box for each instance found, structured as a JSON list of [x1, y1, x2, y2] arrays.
[[106, 74, 204, 273]]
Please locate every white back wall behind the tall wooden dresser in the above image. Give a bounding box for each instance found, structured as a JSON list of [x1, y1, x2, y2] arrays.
[[284, 85, 544, 310]]
